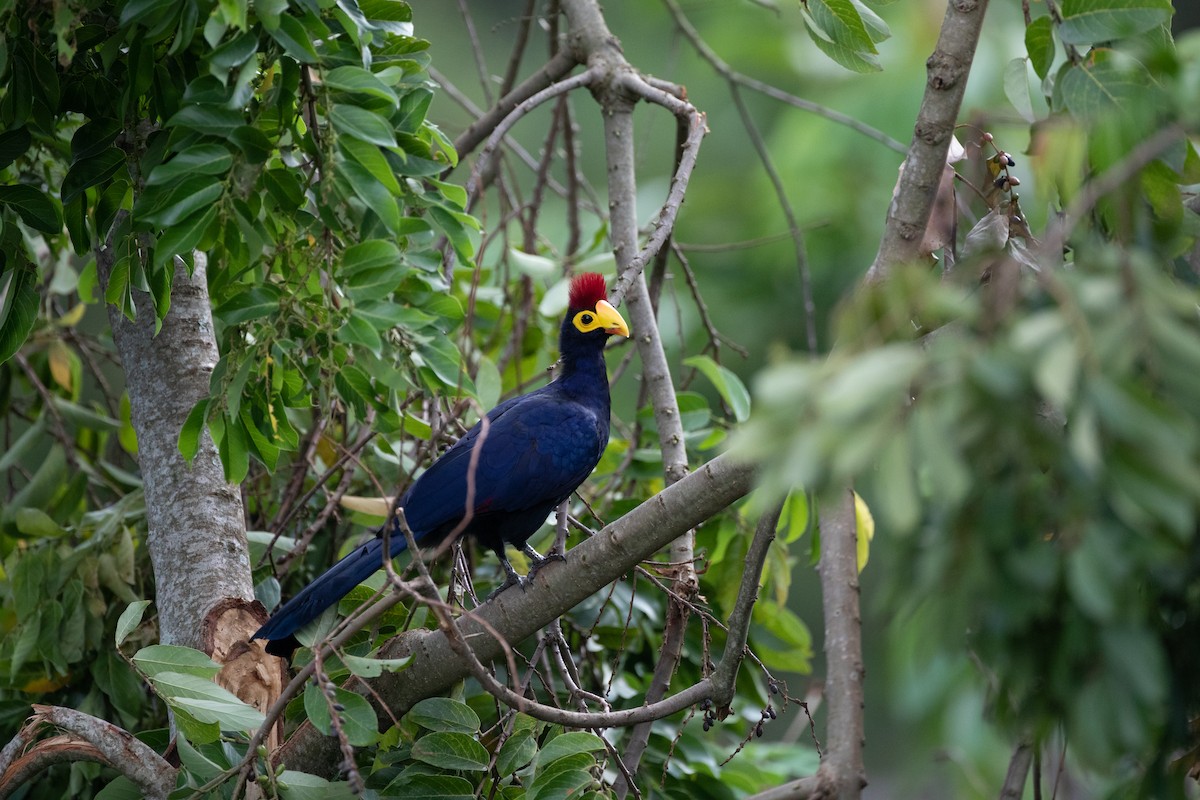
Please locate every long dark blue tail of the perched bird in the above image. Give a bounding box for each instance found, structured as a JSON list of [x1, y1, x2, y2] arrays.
[[250, 535, 408, 656]]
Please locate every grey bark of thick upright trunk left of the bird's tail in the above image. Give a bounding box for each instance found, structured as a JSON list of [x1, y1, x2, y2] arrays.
[[98, 249, 254, 649]]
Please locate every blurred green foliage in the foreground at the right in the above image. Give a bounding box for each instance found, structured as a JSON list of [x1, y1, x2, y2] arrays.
[[744, 4, 1200, 796]]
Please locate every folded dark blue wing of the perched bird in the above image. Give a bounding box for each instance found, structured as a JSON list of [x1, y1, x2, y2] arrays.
[[401, 392, 607, 534]]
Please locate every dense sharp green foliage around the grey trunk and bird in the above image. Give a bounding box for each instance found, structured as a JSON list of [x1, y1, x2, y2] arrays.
[[0, 0, 814, 798]]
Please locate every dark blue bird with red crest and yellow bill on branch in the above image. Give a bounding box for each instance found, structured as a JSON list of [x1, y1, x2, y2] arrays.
[[252, 272, 629, 655]]
